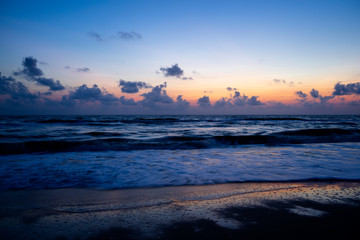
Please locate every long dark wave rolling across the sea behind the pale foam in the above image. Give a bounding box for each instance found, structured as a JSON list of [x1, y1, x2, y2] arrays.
[[0, 128, 360, 155]]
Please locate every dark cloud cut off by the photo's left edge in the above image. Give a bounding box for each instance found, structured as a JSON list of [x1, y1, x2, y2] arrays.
[[0, 73, 39, 101]]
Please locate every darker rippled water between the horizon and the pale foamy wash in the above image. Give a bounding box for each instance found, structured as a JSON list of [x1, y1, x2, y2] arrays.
[[0, 116, 360, 154]]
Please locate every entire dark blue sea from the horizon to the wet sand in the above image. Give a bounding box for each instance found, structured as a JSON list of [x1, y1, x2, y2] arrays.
[[0, 115, 360, 191]]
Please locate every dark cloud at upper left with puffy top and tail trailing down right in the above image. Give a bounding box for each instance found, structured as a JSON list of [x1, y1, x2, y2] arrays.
[[14, 57, 65, 91]]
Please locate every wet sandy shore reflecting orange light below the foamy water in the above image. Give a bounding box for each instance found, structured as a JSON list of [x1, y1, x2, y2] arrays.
[[0, 182, 360, 239]]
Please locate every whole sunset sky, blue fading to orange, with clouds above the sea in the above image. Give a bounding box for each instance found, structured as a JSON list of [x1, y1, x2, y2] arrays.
[[0, 0, 360, 115]]
